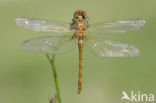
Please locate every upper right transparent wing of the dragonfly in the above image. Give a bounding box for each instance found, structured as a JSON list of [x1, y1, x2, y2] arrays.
[[87, 20, 146, 34]]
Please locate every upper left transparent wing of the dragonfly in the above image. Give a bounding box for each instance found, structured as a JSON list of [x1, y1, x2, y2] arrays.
[[15, 18, 72, 33]]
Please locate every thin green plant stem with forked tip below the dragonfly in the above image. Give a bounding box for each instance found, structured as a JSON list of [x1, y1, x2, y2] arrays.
[[46, 55, 62, 103]]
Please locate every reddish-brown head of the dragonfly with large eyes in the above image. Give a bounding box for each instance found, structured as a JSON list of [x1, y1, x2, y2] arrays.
[[74, 9, 88, 19]]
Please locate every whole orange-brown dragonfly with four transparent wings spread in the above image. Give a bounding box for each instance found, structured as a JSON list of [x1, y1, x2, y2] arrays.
[[15, 9, 146, 94]]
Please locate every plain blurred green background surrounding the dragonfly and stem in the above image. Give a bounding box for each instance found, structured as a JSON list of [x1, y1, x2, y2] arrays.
[[0, 0, 156, 103]]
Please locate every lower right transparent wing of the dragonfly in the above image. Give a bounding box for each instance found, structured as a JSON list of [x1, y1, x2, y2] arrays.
[[86, 37, 140, 57]]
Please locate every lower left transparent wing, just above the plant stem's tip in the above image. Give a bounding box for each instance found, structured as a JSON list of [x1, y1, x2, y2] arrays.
[[21, 36, 76, 54]]
